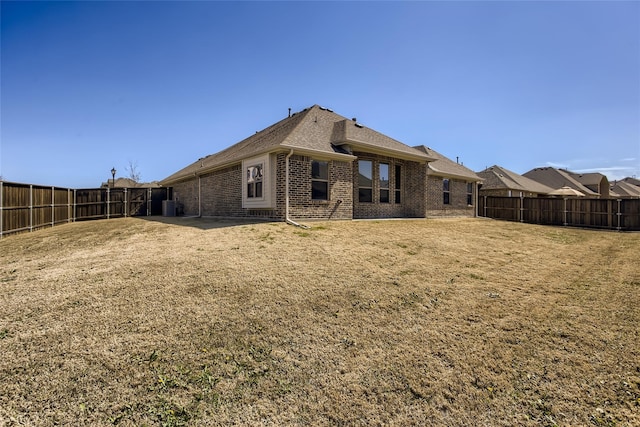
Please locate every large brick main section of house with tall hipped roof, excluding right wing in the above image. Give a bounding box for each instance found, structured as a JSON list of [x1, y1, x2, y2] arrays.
[[161, 105, 434, 221]]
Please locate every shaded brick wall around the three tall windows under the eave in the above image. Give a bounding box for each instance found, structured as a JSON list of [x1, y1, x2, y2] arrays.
[[352, 152, 426, 218]]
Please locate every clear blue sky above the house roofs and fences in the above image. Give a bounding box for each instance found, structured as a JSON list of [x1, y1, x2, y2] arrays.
[[0, 1, 640, 188]]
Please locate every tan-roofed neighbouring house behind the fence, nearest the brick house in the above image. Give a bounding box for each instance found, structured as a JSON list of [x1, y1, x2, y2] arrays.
[[477, 165, 553, 197]]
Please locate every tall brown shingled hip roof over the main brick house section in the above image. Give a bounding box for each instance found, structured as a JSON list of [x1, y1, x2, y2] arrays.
[[161, 105, 432, 185]]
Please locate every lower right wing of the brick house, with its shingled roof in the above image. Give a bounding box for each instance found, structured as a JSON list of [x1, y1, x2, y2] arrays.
[[415, 145, 482, 216]]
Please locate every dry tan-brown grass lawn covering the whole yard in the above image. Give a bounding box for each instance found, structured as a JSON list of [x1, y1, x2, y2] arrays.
[[0, 218, 640, 426]]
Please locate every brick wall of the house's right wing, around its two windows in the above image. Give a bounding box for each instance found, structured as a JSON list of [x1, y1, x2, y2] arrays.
[[427, 175, 475, 216]]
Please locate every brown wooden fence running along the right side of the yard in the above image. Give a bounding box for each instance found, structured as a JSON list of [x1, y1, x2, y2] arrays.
[[478, 196, 640, 231]]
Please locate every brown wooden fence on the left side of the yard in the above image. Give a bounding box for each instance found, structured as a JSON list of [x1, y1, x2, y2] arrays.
[[0, 181, 171, 238]]
